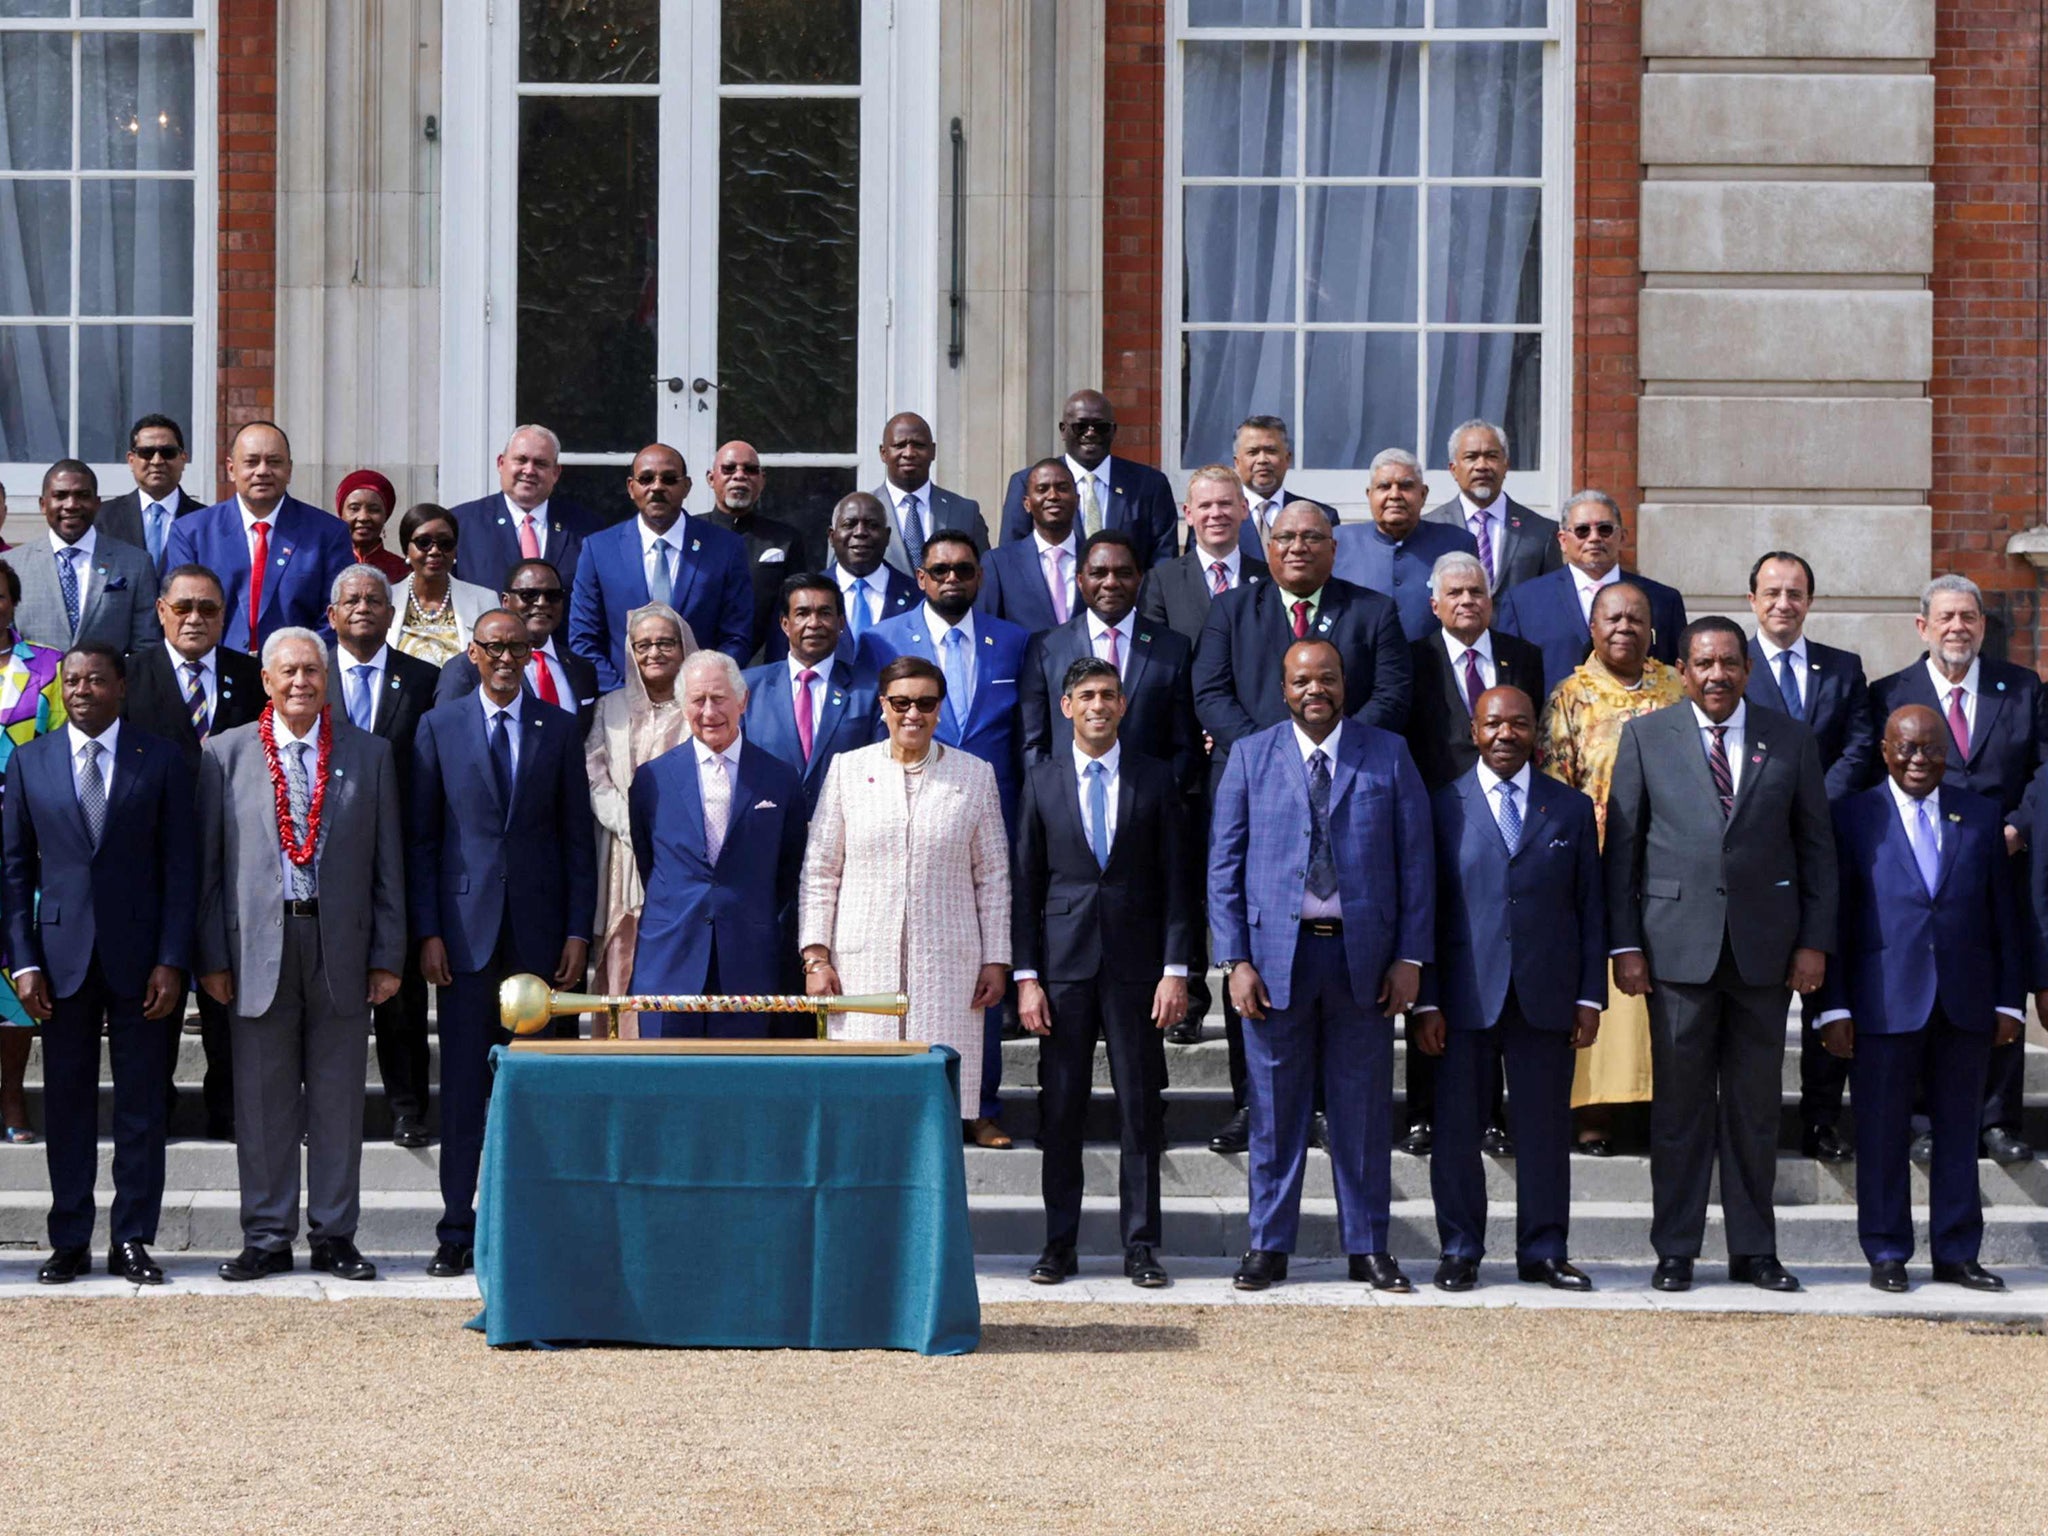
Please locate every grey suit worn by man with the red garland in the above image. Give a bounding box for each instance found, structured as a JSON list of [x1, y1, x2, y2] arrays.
[[197, 711, 406, 1249]]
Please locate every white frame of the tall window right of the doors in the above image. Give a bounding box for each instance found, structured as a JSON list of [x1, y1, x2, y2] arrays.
[[1159, 0, 1577, 516]]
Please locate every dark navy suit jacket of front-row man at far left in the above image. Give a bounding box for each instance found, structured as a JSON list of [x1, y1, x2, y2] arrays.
[[0, 723, 199, 997]]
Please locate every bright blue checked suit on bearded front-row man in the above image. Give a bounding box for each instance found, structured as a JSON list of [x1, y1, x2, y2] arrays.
[[1208, 719, 1436, 1253]]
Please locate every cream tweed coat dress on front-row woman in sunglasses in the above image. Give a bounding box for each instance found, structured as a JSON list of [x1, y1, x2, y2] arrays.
[[797, 741, 1010, 1102]]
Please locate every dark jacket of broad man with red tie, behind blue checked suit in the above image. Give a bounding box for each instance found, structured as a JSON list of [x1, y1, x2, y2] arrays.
[[1194, 578, 1409, 768]]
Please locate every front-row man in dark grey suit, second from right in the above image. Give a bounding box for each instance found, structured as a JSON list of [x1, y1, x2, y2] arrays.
[[1604, 616, 1839, 1290]]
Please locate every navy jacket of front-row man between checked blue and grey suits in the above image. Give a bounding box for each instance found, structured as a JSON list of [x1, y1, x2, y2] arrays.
[[1421, 768, 1608, 1030]]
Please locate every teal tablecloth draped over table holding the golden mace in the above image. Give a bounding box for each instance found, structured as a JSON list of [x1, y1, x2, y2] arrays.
[[471, 1049, 981, 1354]]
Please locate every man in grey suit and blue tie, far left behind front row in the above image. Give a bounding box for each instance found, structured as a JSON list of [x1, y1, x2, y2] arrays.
[[8, 459, 160, 655]]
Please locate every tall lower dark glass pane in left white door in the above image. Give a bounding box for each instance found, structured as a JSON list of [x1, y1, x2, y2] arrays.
[[514, 96, 659, 450]]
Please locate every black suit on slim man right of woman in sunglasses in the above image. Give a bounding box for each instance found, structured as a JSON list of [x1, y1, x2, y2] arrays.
[[1010, 750, 1196, 1249]]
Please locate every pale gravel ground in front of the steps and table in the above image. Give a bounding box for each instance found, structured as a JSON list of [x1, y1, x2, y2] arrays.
[[0, 1298, 2048, 1536]]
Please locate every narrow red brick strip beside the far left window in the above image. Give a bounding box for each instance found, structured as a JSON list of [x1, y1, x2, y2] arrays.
[[213, 0, 278, 496]]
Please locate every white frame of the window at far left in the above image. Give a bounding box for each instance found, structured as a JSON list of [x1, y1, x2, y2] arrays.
[[0, 0, 221, 508]]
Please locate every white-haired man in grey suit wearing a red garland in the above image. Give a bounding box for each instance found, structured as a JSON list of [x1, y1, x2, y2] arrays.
[[195, 627, 406, 1280]]
